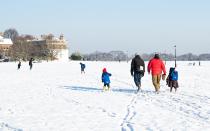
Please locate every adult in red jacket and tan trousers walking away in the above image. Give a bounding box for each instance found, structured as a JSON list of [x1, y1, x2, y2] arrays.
[[147, 54, 166, 93]]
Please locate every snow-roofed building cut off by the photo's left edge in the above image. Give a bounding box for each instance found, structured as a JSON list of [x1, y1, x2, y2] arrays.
[[0, 36, 13, 58]]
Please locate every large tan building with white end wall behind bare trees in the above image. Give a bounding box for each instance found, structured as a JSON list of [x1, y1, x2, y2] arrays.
[[32, 34, 69, 61]]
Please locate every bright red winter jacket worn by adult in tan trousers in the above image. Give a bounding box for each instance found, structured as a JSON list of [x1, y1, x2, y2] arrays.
[[147, 58, 166, 75]]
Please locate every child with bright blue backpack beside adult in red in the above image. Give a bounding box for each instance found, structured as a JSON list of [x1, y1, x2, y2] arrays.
[[166, 67, 179, 92]]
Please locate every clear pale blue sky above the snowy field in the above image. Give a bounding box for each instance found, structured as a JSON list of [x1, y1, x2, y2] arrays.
[[0, 0, 210, 54]]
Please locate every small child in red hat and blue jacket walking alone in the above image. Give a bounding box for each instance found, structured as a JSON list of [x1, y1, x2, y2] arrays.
[[101, 68, 112, 91]]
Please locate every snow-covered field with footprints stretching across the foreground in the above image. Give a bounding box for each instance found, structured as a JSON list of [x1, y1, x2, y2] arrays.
[[0, 61, 210, 131]]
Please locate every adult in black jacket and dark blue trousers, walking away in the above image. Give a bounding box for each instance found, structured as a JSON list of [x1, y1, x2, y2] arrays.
[[131, 54, 145, 91]]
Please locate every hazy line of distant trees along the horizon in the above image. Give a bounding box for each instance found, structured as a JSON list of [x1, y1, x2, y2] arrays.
[[70, 51, 210, 61]]
